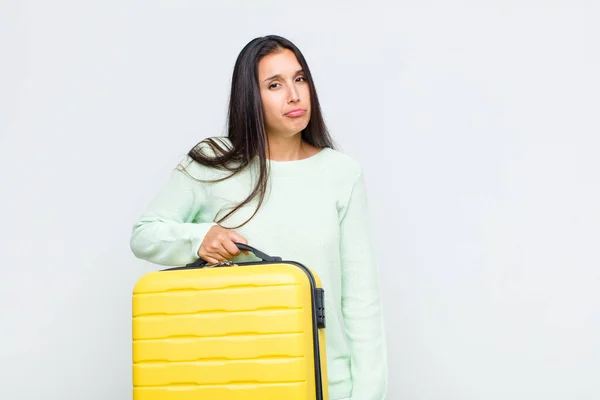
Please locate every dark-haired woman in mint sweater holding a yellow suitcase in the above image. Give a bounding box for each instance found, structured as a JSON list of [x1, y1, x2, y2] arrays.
[[131, 36, 387, 400]]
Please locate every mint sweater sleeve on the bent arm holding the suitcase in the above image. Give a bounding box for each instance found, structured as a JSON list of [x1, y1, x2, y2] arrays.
[[130, 161, 217, 266]]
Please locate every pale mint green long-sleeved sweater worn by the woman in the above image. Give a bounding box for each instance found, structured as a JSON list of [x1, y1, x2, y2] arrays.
[[130, 138, 387, 400]]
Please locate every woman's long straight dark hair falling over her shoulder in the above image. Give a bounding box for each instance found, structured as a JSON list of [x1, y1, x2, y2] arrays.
[[180, 35, 335, 229]]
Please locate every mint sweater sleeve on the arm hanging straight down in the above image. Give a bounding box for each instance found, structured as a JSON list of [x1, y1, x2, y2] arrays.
[[340, 169, 388, 400]]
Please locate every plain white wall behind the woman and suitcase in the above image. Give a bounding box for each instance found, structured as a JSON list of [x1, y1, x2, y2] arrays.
[[0, 0, 600, 400]]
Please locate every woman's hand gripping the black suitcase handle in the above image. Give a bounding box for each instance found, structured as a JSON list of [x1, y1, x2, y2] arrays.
[[198, 225, 248, 264]]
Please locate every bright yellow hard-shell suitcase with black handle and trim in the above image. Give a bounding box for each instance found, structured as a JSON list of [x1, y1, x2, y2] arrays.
[[132, 243, 328, 400]]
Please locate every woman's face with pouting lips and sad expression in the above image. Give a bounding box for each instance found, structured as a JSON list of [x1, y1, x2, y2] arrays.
[[258, 49, 310, 137]]
